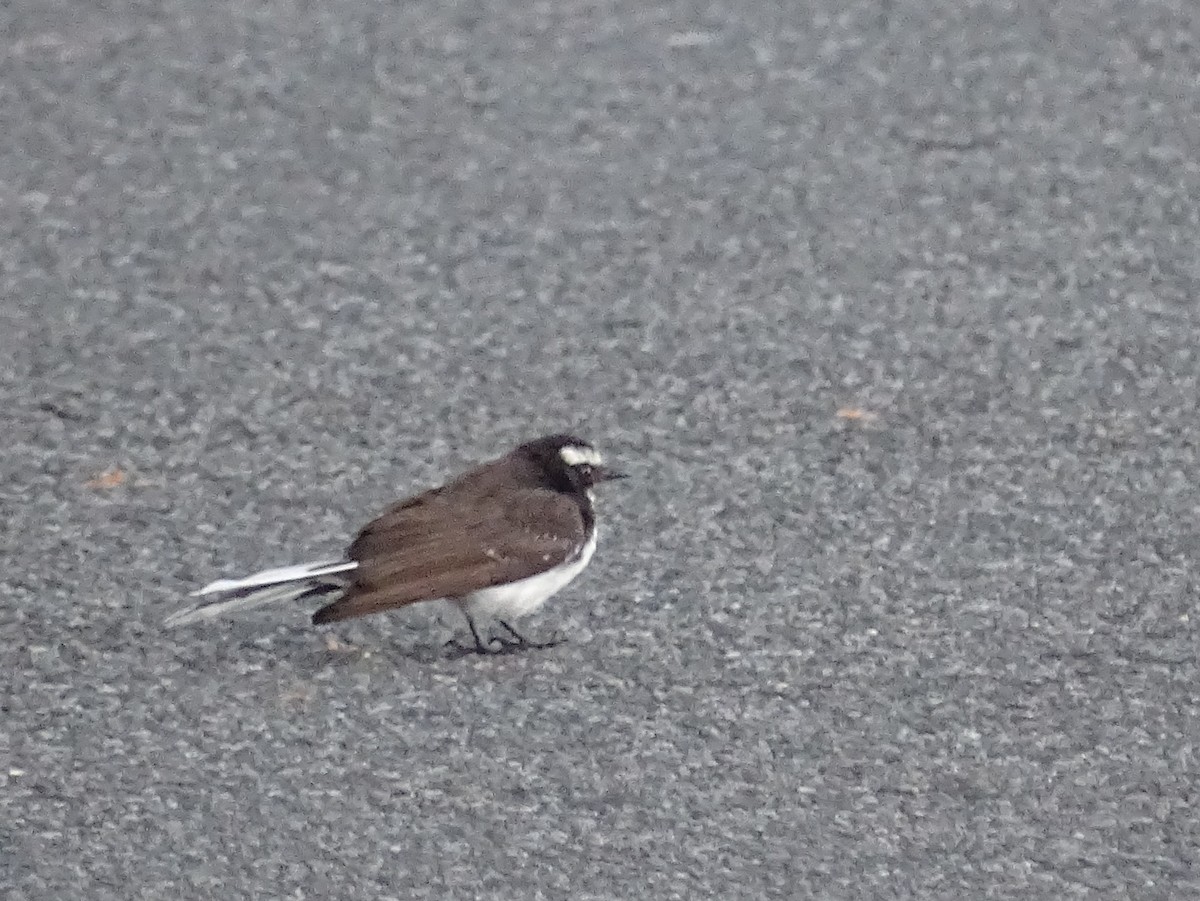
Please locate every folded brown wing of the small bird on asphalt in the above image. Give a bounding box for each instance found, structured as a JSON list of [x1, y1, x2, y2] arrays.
[[313, 488, 584, 623]]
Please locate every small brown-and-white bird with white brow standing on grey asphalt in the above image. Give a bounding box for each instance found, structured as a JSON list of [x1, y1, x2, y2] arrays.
[[164, 433, 626, 654]]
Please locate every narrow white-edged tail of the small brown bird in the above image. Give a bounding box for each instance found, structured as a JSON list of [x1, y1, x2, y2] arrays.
[[163, 560, 358, 627]]
